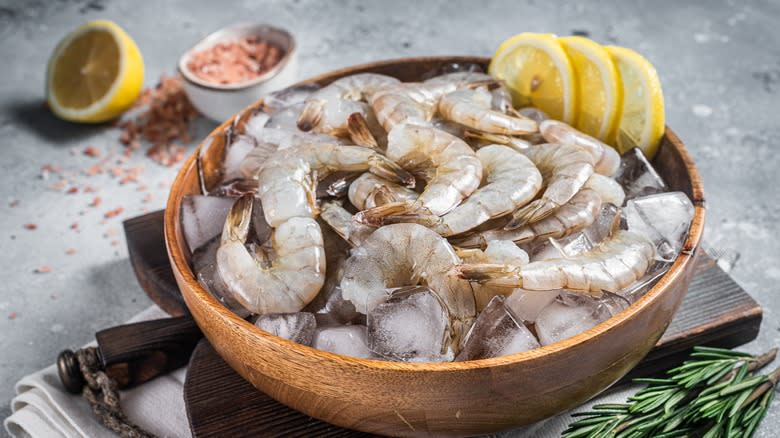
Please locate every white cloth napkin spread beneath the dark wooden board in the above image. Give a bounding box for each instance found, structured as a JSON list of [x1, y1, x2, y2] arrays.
[[3, 306, 637, 438]]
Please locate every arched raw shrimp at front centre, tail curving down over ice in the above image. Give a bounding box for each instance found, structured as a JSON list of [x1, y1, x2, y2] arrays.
[[341, 224, 476, 345]]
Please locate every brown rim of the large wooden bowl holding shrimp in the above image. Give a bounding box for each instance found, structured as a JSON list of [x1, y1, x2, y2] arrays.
[[164, 56, 706, 373]]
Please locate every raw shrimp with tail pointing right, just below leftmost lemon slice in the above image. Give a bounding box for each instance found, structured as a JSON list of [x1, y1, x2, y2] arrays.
[[438, 88, 538, 135]]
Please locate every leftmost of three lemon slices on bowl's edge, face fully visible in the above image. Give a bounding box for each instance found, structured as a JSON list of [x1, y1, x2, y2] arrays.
[[488, 33, 577, 123]]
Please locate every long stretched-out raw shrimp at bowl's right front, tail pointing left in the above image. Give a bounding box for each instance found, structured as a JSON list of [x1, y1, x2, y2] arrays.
[[454, 230, 656, 295]]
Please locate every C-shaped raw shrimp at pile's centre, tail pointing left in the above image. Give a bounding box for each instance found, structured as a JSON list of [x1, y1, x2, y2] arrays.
[[356, 123, 482, 224]]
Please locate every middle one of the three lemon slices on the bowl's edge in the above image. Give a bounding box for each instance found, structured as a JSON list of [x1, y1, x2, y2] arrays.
[[558, 36, 623, 141]]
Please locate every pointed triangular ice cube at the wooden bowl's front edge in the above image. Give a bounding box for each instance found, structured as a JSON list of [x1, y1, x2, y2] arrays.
[[455, 295, 539, 361]]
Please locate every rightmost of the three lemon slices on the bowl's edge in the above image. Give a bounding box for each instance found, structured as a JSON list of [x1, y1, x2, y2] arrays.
[[605, 46, 664, 158]]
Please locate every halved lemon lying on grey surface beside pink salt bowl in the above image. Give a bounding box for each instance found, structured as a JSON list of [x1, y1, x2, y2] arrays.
[[46, 20, 144, 123]]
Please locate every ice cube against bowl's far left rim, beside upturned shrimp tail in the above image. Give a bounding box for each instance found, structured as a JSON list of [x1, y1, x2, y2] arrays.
[[181, 195, 235, 251]]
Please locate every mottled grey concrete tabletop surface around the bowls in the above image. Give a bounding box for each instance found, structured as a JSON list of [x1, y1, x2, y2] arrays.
[[0, 0, 780, 437]]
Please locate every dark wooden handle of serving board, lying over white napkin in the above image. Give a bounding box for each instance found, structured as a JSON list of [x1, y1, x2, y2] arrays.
[[95, 316, 203, 388]]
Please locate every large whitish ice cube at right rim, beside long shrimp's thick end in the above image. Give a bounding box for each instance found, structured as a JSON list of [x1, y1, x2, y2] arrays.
[[623, 192, 694, 261]]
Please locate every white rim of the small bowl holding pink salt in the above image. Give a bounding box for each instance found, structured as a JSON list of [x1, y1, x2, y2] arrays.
[[176, 22, 297, 92]]
